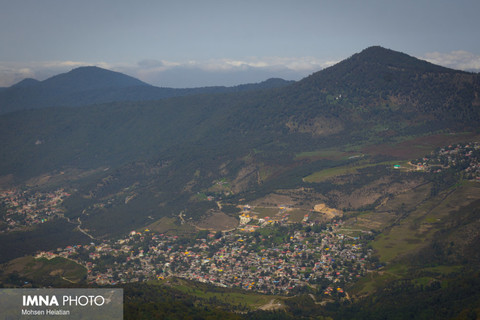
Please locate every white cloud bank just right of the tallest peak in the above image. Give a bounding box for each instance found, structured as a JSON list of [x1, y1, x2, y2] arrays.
[[424, 50, 480, 71]]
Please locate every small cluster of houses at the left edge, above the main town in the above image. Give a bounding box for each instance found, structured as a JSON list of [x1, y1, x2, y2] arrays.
[[0, 189, 70, 232]]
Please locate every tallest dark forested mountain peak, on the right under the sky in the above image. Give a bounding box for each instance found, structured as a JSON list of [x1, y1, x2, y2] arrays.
[[285, 46, 480, 125]]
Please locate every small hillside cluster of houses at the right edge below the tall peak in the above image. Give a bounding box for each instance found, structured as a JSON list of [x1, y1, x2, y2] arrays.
[[412, 142, 480, 181]]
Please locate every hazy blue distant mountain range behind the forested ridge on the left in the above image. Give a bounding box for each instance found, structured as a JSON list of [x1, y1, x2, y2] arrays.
[[0, 67, 294, 113]]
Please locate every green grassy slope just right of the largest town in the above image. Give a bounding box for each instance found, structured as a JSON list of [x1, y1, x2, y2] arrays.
[[344, 182, 480, 296]]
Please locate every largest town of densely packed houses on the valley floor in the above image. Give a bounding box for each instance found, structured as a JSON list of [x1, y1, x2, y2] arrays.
[[39, 221, 373, 295]]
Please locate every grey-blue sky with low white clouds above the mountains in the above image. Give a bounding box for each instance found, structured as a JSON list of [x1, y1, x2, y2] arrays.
[[0, 0, 480, 88]]
